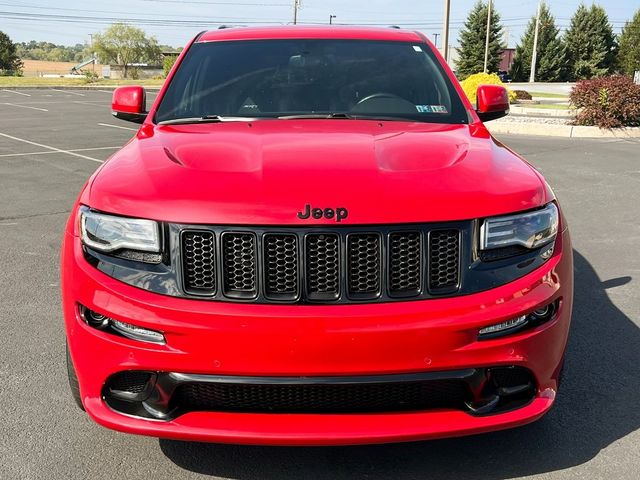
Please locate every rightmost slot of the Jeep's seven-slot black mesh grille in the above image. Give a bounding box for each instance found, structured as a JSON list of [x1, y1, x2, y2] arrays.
[[429, 230, 460, 290]]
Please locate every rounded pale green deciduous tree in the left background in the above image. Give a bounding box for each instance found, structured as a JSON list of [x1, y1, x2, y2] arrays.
[[93, 23, 162, 78]]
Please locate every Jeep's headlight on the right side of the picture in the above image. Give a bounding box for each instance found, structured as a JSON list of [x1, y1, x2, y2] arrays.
[[480, 203, 558, 250]]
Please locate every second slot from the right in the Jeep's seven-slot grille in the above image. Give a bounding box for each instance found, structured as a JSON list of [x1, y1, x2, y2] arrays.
[[389, 232, 422, 296]]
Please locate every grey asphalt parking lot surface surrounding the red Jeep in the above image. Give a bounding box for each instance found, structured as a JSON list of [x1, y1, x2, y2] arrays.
[[0, 89, 640, 480]]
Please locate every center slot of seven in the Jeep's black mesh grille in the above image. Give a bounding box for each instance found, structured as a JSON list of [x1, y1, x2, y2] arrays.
[[306, 234, 340, 300]]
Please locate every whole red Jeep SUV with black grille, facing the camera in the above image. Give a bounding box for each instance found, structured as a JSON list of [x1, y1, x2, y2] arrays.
[[62, 26, 573, 445]]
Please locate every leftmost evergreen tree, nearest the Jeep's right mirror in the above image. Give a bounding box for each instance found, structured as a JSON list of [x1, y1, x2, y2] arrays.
[[456, 0, 504, 79]]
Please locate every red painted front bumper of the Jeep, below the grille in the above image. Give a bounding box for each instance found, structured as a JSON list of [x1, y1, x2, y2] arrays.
[[62, 227, 573, 445]]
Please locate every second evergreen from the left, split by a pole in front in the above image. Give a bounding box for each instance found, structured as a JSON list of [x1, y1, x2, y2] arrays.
[[511, 3, 566, 82]]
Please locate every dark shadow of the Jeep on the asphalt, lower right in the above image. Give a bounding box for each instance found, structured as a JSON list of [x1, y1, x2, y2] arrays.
[[160, 252, 640, 480]]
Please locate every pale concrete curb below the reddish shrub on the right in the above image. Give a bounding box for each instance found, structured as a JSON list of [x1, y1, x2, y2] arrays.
[[485, 122, 640, 138]]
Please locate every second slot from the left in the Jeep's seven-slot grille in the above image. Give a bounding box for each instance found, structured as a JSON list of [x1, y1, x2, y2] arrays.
[[222, 232, 257, 298]]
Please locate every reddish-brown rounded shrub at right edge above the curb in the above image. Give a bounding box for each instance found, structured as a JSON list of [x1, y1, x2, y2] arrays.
[[570, 75, 640, 128]]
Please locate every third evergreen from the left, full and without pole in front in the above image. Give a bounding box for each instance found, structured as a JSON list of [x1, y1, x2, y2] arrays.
[[564, 4, 616, 80]]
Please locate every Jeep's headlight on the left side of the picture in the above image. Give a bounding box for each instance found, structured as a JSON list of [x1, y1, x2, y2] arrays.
[[80, 207, 160, 252]]
